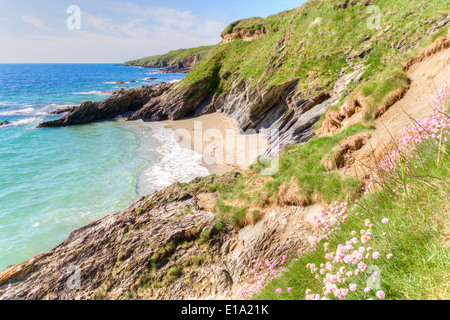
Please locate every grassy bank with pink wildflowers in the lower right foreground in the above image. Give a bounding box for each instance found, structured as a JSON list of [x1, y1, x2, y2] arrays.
[[253, 88, 450, 300]]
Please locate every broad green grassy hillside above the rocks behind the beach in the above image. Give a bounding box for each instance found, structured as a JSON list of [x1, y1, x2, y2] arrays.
[[180, 0, 449, 99]]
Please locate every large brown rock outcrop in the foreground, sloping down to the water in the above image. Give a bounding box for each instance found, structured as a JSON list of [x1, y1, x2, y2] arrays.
[[0, 173, 321, 299]]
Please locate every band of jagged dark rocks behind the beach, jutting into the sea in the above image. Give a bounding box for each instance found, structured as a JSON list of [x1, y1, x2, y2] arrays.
[[38, 63, 365, 156]]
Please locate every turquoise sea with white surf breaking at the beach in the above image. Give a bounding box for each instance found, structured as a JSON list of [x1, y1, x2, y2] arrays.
[[0, 64, 207, 270]]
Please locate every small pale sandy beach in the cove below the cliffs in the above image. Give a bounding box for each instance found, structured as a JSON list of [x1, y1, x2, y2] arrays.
[[166, 113, 269, 175]]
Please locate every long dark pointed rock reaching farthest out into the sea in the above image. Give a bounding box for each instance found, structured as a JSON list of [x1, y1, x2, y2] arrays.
[[38, 83, 173, 128]]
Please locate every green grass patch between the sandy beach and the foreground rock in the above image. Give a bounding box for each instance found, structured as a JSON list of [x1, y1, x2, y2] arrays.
[[215, 124, 371, 230]]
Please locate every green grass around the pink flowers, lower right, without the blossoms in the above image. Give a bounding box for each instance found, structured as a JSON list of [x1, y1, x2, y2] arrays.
[[256, 117, 450, 300]]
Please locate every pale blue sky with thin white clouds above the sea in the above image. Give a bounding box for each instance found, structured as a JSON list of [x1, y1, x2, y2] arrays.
[[0, 0, 305, 63]]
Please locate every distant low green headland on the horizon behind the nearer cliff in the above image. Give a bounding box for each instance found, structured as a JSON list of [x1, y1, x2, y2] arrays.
[[124, 46, 214, 68]]
